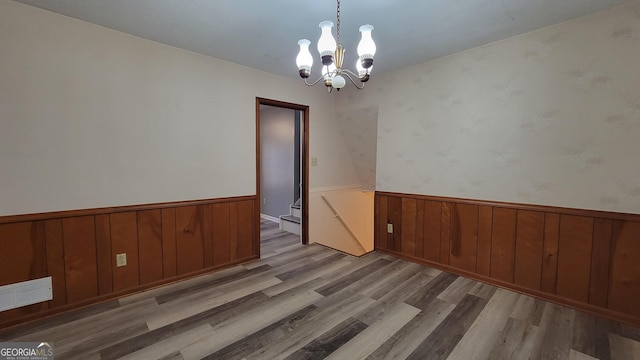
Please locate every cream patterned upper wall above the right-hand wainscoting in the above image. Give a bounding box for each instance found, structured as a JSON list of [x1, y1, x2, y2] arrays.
[[336, 2, 640, 213]]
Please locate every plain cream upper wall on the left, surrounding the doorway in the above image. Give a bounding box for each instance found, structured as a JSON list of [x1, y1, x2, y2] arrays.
[[0, 0, 358, 215]]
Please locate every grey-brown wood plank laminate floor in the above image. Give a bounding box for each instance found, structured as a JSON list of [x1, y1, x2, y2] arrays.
[[0, 222, 640, 360]]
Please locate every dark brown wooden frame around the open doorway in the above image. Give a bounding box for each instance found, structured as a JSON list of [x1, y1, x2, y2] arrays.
[[254, 97, 309, 255]]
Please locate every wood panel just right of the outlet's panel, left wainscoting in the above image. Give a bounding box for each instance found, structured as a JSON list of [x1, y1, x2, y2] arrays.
[[138, 209, 164, 285]]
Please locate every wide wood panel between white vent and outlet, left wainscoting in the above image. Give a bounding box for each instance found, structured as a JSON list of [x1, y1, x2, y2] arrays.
[[62, 215, 99, 304]]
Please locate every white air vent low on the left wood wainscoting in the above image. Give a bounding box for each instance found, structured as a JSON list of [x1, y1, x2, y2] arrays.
[[0, 276, 53, 311]]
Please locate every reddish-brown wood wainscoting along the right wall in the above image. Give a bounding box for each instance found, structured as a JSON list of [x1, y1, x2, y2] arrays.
[[375, 192, 640, 326]]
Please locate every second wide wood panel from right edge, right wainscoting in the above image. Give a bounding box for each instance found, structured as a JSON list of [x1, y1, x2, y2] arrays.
[[556, 214, 593, 303]]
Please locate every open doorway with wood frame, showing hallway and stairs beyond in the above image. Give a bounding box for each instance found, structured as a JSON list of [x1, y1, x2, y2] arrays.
[[256, 98, 309, 250]]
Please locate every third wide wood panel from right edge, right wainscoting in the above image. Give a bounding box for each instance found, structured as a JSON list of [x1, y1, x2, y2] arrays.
[[513, 210, 544, 290]]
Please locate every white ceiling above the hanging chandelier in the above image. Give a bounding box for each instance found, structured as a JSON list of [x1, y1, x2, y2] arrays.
[[12, 0, 637, 77]]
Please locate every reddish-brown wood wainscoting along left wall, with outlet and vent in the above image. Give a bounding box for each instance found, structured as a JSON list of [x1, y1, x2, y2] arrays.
[[0, 196, 260, 328]]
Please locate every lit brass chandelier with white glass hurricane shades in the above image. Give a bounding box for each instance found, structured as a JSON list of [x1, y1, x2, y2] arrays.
[[296, 0, 376, 92]]
